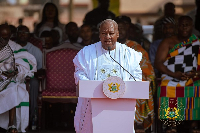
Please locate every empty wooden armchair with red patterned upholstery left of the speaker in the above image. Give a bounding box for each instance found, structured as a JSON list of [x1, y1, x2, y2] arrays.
[[38, 45, 78, 130]]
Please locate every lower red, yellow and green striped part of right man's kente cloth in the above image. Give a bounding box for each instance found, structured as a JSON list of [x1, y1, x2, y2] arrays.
[[158, 84, 200, 120]]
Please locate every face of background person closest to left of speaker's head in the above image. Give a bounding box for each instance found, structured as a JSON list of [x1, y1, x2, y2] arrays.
[[80, 26, 92, 41]]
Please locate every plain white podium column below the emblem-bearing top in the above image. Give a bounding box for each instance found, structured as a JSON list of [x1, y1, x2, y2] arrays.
[[91, 98, 136, 133]]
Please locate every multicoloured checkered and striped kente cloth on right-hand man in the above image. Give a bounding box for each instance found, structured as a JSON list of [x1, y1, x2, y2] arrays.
[[157, 35, 200, 120]]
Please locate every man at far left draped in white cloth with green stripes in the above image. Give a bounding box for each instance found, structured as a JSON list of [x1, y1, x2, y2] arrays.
[[0, 24, 37, 133]]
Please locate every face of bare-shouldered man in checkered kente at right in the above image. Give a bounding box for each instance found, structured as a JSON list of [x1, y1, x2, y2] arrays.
[[178, 18, 193, 38]]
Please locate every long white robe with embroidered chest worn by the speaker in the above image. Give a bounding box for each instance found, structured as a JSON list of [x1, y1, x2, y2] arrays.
[[73, 42, 142, 133]]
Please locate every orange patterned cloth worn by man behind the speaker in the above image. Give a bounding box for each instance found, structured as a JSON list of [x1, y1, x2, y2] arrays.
[[126, 40, 156, 130]]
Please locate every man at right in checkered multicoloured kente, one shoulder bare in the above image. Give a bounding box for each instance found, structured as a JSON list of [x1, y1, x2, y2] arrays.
[[155, 16, 200, 132]]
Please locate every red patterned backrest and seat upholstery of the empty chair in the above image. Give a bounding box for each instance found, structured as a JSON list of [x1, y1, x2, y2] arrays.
[[42, 49, 78, 98]]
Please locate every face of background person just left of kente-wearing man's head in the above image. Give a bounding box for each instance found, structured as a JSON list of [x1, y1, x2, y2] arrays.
[[163, 23, 176, 38]]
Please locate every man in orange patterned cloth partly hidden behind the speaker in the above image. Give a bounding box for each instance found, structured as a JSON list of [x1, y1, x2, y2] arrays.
[[117, 20, 156, 133]]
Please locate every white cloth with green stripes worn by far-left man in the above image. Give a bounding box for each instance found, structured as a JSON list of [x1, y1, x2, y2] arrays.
[[0, 40, 37, 132]]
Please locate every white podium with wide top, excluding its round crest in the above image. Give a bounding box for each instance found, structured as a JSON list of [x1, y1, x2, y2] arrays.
[[77, 80, 149, 133]]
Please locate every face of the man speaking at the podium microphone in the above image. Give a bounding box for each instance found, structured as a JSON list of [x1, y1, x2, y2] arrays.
[[99, 22, 119, 50]]
